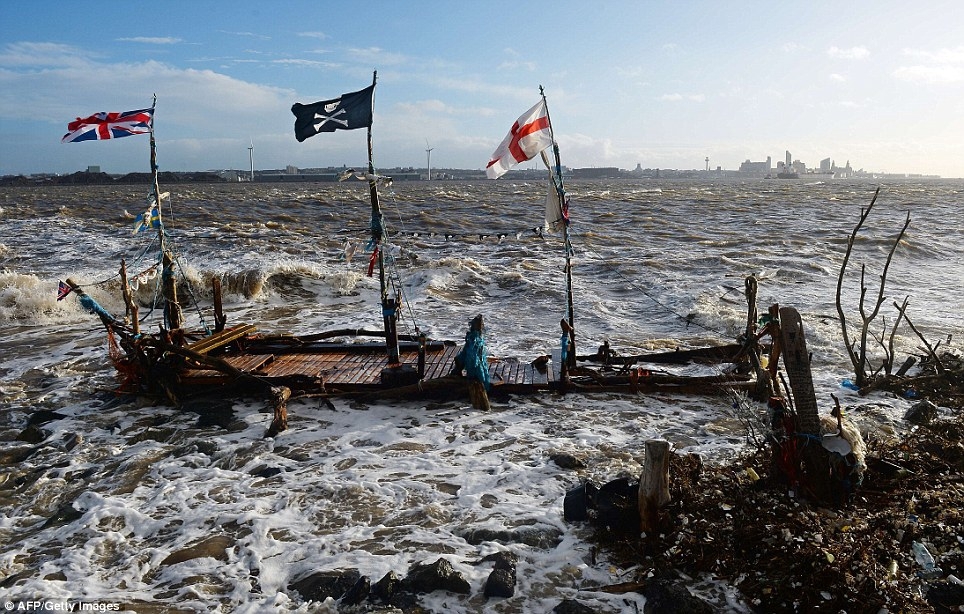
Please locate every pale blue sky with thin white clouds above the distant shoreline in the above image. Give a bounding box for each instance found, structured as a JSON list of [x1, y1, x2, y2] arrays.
[[0, 0, 964, 177]]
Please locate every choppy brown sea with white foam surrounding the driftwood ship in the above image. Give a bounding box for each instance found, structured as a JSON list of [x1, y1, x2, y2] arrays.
[[0, 179, 964, 613]]
